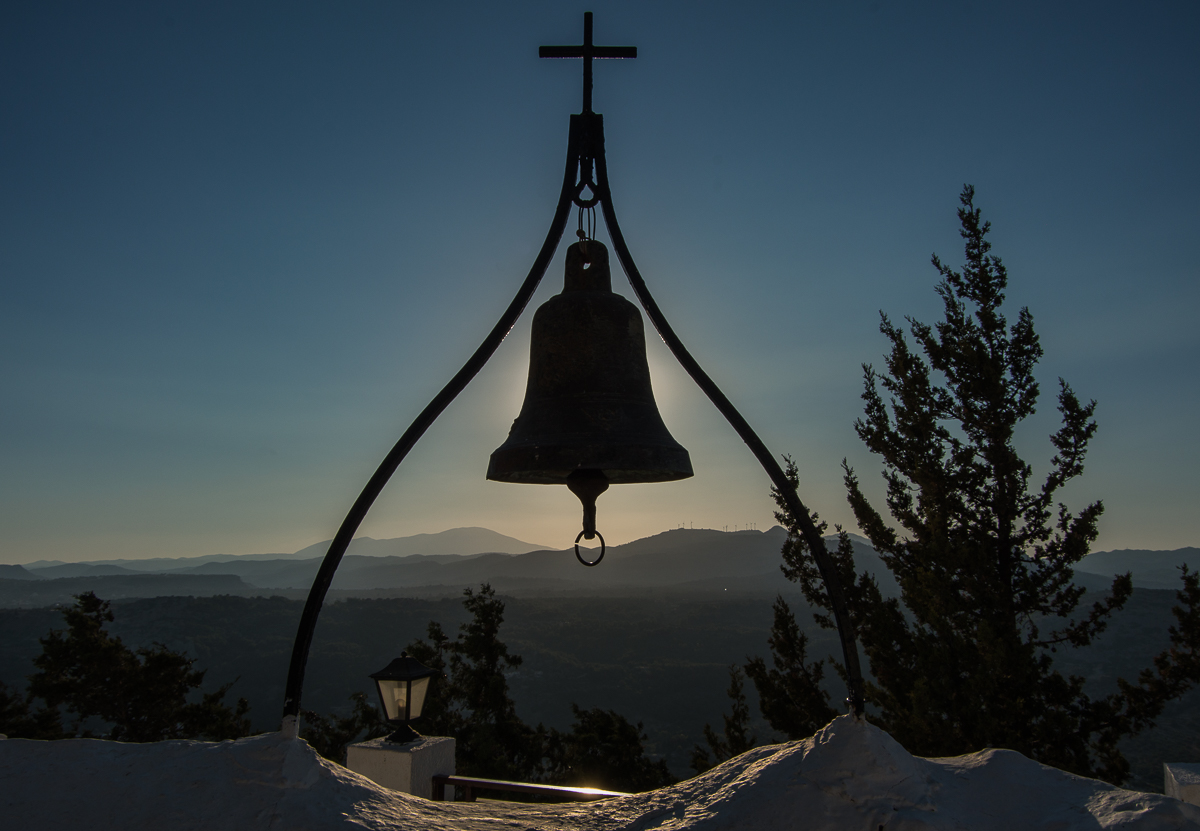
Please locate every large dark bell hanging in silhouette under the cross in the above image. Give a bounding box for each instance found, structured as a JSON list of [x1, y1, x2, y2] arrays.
[[487, 240, 692, 554]]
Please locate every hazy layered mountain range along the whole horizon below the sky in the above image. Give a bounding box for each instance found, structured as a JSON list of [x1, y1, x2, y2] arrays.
[[0, 526, 1200, 608]]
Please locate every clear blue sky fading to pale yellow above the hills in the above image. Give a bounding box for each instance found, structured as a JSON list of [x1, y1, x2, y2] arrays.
[[0, 0, 1200, 563]]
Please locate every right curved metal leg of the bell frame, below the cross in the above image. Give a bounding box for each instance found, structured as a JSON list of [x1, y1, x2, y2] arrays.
[[584, 113, 864, 716]]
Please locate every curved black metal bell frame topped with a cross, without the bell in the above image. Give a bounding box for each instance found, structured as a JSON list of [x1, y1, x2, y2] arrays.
[[281, 12, 864, 737]]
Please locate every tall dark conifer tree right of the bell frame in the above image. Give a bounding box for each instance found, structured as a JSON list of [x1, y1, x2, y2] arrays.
[[776, 186, 1200, 783]]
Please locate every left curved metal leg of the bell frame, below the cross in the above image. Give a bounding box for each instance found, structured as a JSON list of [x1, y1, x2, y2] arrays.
[[282, 119, 582, 736]]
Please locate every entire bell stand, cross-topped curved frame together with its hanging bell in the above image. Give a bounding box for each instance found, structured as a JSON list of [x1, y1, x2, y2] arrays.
[[281, 12, 864, 737]]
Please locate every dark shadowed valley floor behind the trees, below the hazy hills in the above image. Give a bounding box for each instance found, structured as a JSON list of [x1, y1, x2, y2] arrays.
[[0, 588, 1185, 789]]
